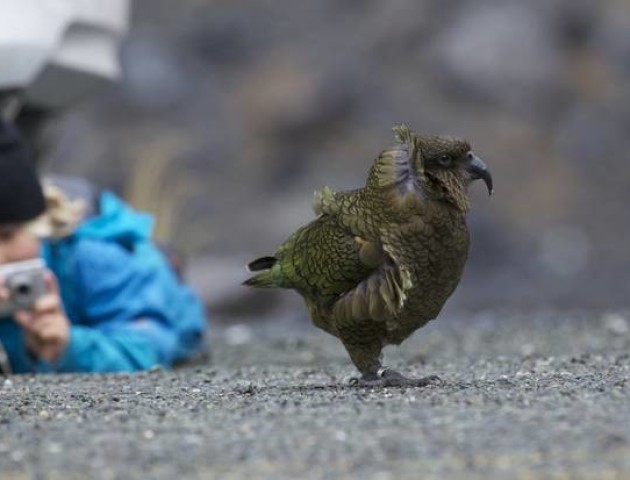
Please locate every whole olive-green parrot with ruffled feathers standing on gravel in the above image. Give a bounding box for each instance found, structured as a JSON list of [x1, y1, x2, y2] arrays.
[[244, 125, 493, 386]]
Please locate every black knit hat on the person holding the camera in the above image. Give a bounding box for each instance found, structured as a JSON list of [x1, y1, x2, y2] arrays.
[[0, 120, 46, 223]]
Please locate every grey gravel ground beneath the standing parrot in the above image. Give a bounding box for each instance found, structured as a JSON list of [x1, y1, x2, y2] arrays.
[[0, 312, 630, 479]]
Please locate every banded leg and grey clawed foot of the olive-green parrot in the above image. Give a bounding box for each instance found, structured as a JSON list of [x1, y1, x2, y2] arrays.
[[342, 339, 442, 387]]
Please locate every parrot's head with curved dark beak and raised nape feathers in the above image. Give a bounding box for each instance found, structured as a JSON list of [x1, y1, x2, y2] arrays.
[[394, 125, 493, 211]]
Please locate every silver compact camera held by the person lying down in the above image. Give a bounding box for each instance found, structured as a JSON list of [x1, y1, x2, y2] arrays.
[[0, 258, 46, 318]]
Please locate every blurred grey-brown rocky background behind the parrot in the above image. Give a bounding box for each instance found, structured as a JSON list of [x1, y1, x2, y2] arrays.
[[40, 0, 630, 324]]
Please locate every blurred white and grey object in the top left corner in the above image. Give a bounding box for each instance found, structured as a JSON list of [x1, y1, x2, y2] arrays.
[[0, 0, 130, 108]]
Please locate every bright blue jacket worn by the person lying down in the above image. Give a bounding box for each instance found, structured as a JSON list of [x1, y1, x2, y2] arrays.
[[0, 192, 206, 373]]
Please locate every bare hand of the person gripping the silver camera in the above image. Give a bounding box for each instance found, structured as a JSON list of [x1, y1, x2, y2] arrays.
[[10, 270, 70, 362]]
